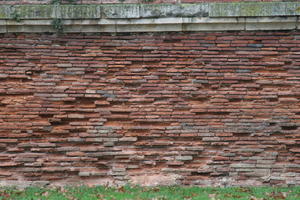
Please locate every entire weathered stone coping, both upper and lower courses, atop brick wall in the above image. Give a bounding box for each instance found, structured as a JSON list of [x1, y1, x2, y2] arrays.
[[0, 2, 300, 33]]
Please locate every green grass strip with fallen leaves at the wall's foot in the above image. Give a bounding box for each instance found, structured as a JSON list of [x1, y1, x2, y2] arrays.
[[0, 186, 300, 200]]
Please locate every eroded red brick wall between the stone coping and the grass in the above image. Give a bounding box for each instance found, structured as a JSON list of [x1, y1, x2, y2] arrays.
[[0, 31, 300, 185]]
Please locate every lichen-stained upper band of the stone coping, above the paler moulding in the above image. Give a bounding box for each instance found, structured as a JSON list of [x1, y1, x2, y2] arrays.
[[0, 2, 300, 20]]
